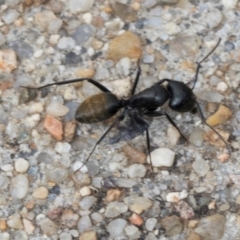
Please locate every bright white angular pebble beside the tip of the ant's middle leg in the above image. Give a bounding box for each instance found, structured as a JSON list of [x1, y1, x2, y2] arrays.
[[147, 148, 175, 167]]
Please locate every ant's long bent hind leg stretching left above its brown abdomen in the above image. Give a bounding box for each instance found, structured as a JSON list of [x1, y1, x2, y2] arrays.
[[22, 78, 111, 92]]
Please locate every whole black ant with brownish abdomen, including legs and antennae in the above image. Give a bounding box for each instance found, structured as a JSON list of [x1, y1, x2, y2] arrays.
[[25, 39, 231, 171]]
